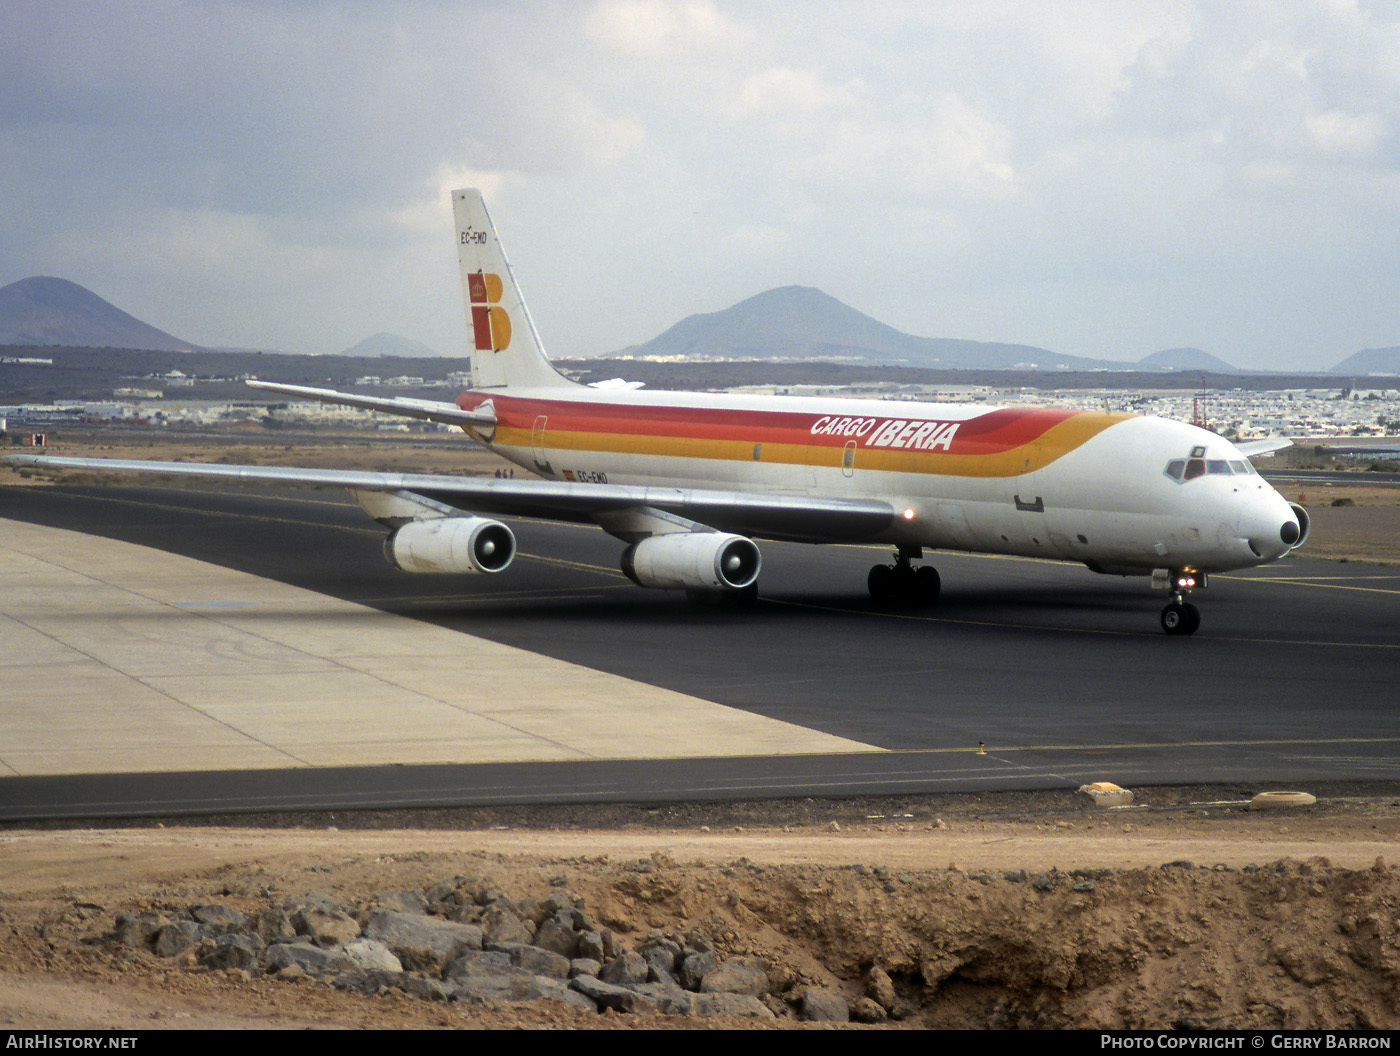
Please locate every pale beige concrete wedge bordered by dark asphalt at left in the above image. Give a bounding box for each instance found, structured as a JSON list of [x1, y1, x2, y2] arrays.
[[0, 520, 872, 774]]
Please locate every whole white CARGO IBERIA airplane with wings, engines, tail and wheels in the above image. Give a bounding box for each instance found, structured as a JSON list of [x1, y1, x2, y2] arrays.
[[8, 190, 1309, 634]]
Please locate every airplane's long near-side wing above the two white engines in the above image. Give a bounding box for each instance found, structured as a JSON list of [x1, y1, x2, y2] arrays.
[[4, 455, 896, 542]]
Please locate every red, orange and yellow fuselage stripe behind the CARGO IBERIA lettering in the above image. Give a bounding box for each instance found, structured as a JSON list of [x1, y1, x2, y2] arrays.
[[458, 392, 1134, 476]]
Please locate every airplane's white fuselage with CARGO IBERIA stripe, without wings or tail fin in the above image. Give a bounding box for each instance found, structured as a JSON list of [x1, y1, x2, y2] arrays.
[[458, 388, 1299, 574]]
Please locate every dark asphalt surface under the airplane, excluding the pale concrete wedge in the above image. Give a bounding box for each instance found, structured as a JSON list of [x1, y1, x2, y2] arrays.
[[0, 486, 1400, 817]]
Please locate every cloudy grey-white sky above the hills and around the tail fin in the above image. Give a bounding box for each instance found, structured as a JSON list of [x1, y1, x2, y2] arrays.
[[0, 0, 1400, 370]]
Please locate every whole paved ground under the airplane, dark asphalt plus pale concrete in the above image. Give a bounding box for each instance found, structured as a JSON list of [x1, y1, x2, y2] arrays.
[[0, 486, 1400, 819]]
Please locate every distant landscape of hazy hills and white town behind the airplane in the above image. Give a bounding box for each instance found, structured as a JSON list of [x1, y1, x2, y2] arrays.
[[0, 277, 1400, 458]]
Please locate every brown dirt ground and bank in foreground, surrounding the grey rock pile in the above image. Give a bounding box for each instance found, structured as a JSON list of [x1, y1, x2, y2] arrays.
[[0, 786, 1400, 1029]]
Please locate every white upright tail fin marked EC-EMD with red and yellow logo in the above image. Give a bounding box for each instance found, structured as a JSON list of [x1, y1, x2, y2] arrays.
[[452, 190, 573, 389]]
